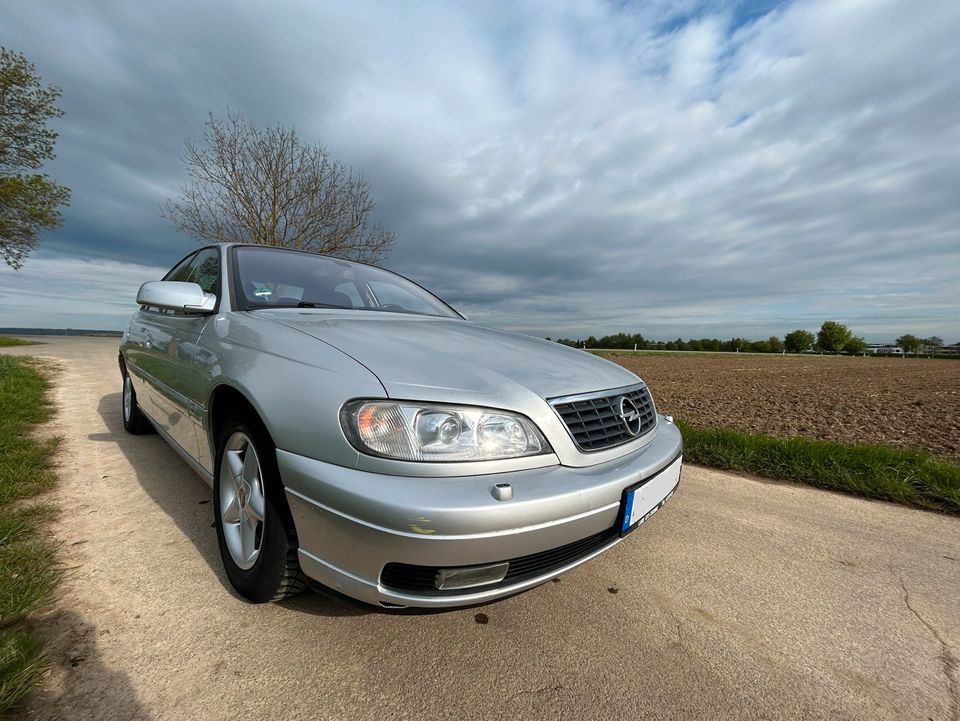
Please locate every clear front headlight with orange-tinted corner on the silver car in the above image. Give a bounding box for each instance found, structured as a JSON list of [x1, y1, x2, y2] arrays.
[[340, 401, 551, 461]]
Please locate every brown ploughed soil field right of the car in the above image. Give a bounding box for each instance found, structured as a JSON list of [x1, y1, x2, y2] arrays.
[[610, 353, 960, 463]]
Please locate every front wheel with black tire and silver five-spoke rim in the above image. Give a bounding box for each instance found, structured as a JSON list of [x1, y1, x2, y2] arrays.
[[213, 415, 307, 603]]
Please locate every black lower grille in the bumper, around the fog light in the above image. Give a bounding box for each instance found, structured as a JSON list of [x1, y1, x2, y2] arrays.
[[380, 528, 618, 596]]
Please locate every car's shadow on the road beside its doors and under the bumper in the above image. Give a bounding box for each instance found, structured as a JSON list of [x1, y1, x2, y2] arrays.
[[94, 393, 366, 616]]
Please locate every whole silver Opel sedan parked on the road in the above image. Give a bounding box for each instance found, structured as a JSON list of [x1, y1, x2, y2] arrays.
[[119, 244, 681, 607]]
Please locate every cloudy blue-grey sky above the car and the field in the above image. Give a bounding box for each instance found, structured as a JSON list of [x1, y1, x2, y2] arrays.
[[0, 0, 960, 342]]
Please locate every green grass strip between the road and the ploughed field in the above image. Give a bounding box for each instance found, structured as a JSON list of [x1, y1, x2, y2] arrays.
[[677, 421, 960, 515]]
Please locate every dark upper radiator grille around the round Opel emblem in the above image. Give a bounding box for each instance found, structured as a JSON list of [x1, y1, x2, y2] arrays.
[[551, 386, 657, 451]]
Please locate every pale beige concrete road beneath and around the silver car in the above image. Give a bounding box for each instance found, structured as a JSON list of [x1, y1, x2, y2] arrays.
[[3, 338, 960, 721]]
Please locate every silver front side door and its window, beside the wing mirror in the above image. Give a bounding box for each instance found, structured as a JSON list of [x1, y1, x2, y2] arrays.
[[139, 248, 220, 459]]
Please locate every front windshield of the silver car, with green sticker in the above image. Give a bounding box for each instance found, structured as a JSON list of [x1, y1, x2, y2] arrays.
[[236, 247, 460, 318]]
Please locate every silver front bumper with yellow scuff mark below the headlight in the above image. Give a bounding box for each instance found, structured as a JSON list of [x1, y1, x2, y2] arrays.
[[277, 417, 681, 607]]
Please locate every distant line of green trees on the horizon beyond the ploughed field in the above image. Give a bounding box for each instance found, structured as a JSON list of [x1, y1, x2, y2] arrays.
[[547, 320, 943, 354]]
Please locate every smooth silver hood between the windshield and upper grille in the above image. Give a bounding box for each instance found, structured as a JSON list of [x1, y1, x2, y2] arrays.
[[260, 310, 637, 403]]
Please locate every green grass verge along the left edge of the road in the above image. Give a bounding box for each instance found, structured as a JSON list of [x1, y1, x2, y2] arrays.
[[0, 356, 59, 715]]
